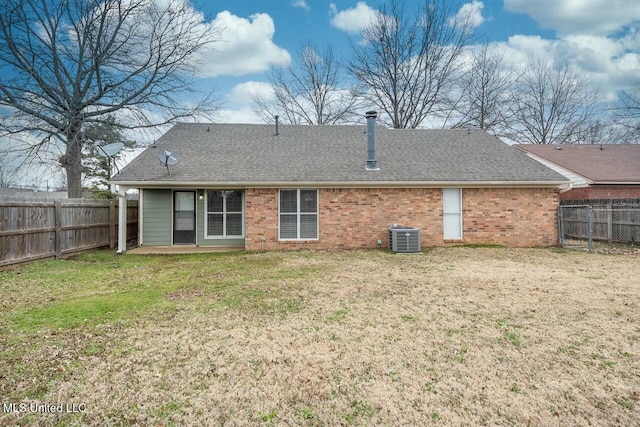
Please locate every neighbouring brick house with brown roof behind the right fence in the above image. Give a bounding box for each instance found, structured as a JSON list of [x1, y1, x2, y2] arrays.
[[515, 144, 640, 200]]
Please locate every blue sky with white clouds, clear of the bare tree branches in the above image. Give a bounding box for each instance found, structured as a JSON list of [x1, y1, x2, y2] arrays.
[[186, 0, 640, 123]]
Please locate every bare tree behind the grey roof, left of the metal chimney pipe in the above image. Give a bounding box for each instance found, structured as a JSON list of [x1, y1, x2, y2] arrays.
[[253, 42, 361, 125]]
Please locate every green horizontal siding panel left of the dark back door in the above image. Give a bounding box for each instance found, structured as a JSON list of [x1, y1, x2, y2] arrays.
[[142, 189, 173, 246]]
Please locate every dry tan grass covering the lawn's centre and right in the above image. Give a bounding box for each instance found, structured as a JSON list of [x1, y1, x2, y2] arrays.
[[0, 248, 640, 425]]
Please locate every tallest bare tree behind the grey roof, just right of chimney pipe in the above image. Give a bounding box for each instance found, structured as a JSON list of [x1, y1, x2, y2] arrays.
[[348, 0, 472, 128]]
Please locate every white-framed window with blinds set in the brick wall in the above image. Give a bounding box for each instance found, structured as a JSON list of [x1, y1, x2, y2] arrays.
[[280, 189, 318, 240]]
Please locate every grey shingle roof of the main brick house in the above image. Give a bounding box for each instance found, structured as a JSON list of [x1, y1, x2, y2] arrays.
[[111, 123, 567, 186]]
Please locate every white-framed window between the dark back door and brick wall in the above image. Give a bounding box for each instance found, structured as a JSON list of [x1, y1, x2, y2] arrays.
[[205, 190, 244, 237]]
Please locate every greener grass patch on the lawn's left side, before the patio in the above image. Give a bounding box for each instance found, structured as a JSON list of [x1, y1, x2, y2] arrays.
[[0, 251, 325, 331]]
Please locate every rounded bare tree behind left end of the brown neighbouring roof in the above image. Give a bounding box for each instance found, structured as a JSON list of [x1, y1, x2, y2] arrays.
[[509, 59, 598, 144]]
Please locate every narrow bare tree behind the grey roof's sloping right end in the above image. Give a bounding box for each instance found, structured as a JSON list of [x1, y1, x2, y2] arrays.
[[450, 42, 518, 135]]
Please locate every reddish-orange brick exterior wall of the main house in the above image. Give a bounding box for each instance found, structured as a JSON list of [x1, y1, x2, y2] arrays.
[[245, 188, 558, 250]]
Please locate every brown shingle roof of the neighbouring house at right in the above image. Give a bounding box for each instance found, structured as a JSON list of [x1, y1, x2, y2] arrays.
[[516, 144, 640, 184]]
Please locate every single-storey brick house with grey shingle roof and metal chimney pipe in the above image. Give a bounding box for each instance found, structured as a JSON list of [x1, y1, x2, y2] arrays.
[[111, 112, 568, 251]]
